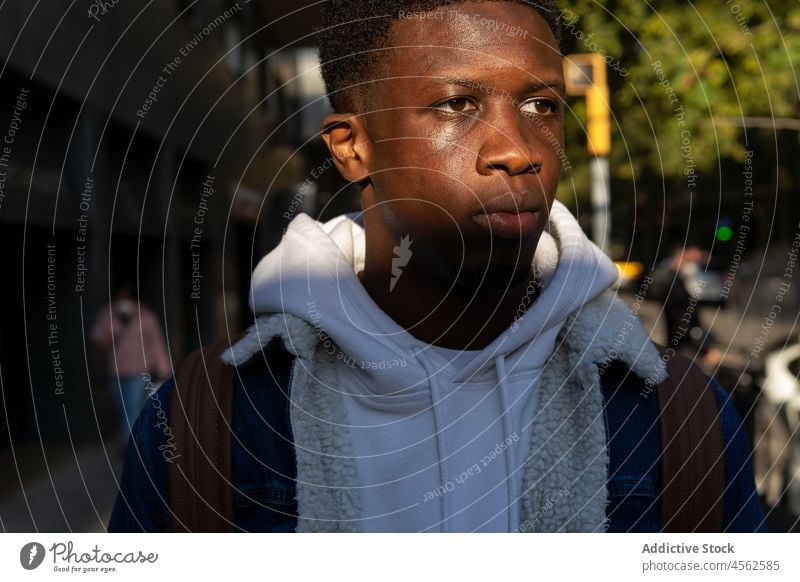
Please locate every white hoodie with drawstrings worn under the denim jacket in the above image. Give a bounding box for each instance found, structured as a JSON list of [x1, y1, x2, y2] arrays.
[[251, 202, 617, 532]]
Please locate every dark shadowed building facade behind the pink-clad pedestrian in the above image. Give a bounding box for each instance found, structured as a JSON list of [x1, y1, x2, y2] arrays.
[[0, 0, 341, 448]]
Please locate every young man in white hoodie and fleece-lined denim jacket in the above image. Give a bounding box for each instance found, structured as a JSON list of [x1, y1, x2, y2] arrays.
[[110, 1, 761, 532]]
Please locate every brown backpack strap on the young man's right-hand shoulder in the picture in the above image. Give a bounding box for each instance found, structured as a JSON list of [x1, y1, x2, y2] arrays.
[[657, 354, 725, 533]]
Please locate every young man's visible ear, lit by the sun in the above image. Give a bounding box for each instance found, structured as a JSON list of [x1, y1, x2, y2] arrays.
[[322, 113, 370, 182]]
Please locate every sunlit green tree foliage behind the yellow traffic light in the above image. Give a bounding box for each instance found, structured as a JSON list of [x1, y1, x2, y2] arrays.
[[561, 0, 800, 253]]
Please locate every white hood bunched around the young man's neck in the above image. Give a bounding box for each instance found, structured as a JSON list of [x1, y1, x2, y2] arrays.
[[250, 202, 617, 394]]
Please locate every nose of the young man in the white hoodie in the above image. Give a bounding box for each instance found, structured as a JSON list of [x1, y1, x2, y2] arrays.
[[477, 113, 542, 176]]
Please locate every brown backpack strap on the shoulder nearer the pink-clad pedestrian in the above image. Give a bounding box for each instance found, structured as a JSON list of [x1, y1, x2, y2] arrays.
[[169, 340, 235, 532]]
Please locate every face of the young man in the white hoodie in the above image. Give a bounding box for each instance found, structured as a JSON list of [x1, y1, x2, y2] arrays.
[[363, 2, 564, 287]]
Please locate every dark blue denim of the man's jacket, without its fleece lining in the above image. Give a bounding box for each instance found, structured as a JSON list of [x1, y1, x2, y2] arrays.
[[108, 338, 765, 532]]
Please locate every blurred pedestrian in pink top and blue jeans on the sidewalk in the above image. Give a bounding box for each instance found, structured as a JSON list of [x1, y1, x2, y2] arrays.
[[91, 283, 171, 441]]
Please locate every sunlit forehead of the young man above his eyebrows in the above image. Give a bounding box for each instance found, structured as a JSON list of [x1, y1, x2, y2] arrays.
[[384, 2, 561, 76]]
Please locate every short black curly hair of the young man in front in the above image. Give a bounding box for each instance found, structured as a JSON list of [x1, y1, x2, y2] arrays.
[[317, 0, 561, 113]]
